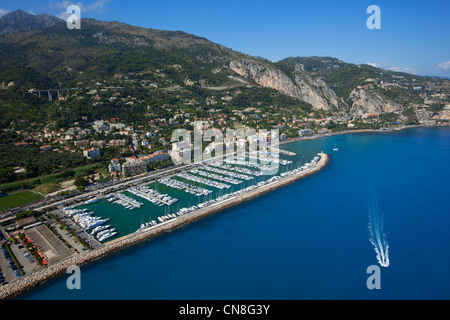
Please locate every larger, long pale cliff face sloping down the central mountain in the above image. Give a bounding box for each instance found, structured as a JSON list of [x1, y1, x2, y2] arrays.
[[229, 59, 341, 110]]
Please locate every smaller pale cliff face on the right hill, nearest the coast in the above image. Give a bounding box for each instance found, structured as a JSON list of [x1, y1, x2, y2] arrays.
[[349, 88, 403, 117]]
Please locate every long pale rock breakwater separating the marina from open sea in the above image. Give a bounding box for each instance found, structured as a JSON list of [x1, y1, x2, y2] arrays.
[[0, 153, 329, 300]]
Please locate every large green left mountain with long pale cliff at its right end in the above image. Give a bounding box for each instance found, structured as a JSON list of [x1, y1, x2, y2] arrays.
[[0, 12, 337, 110]]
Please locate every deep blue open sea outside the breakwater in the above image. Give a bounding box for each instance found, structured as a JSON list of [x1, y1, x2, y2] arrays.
[[19, 127, 450, 300]]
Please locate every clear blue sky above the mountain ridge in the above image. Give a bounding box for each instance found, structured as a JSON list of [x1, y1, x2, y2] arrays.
[[0, 0, 450, 77]]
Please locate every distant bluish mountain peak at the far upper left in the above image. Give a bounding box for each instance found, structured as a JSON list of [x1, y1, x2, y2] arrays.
[[0, 10, 65, 36]]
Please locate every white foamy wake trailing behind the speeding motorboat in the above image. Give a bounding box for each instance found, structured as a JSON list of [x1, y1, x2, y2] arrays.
[[369, 183, 389, 267]]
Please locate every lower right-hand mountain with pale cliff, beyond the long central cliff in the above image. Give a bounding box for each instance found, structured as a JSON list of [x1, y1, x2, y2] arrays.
[[278, 57, 450, 117]]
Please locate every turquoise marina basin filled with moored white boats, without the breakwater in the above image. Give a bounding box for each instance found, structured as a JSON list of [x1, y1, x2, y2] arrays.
[[66, 152, 320, 241]]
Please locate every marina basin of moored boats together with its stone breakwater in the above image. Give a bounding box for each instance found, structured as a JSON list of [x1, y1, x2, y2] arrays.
[[0, 147, 328, 300]]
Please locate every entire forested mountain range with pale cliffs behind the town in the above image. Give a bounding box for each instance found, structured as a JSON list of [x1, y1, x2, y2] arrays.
[[0, 10, 450, 127]]
